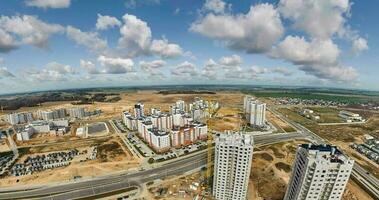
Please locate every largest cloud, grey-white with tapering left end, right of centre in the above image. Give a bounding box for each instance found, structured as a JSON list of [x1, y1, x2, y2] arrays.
[[190, 3, 284, 53]]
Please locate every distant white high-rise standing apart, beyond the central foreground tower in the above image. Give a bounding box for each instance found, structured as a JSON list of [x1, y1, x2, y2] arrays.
[[243, 96, 266, 127]]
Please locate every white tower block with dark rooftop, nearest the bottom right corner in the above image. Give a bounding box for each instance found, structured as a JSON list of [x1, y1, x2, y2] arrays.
[[284, 144, 354, 200]]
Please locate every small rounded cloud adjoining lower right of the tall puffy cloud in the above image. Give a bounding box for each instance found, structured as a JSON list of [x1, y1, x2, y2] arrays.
[[150, 38, 183, 58]]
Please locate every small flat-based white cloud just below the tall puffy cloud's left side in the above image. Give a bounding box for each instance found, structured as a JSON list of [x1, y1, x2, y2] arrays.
[[97, 56, 134, 74]]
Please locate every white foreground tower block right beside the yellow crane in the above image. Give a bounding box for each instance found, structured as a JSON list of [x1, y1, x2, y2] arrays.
[[213, 132, 254, 200]]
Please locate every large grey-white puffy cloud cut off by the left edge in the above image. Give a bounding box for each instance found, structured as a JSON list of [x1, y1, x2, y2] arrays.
[[0, 15, 64, 52]]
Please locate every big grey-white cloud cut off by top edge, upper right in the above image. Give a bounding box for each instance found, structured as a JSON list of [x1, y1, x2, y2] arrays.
[[279, 0, 350, 39]]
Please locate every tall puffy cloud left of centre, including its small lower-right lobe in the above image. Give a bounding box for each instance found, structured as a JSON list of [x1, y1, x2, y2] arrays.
[[118, 14, 183, 58]]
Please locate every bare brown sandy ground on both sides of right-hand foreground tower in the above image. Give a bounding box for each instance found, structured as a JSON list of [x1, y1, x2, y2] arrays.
[[249, 142, 372, 200]]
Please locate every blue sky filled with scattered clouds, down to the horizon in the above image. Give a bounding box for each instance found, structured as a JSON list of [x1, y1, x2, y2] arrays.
[[0, 0, 379, 94]]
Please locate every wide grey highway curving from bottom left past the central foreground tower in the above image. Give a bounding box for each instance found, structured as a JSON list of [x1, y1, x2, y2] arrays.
[[0, 133, 303, 199]]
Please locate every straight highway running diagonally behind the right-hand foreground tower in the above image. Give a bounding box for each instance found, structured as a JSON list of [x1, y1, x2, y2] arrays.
[[269, 108, 379, 199]]
